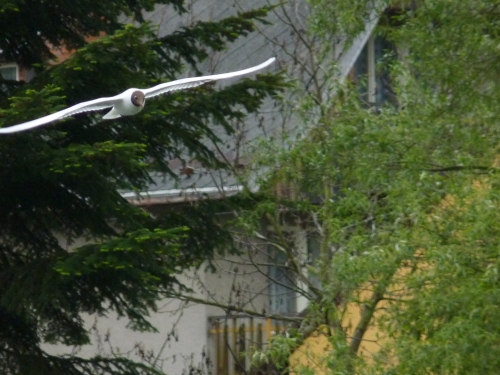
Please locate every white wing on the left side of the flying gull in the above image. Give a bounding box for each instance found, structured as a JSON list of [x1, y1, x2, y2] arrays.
[[0, 96, 118, 134]]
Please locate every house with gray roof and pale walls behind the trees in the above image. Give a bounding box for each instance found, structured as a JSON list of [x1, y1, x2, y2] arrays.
[[0, 0, 386, 375]]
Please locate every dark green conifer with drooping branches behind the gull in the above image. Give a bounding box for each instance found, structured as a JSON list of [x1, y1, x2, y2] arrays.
[[0, 0, 282, 375]]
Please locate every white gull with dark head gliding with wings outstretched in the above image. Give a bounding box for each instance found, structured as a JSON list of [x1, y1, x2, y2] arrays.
[[0, 57, 276, 134]]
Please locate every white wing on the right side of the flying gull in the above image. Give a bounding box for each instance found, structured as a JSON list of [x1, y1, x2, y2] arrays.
[[141, 57, 276, 98]]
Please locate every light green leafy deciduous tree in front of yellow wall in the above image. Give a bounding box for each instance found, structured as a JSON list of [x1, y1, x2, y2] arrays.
[[229, 0, 500, 374]]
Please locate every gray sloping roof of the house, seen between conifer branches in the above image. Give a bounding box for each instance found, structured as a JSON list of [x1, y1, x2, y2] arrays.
[[123, 0, 377, 204]]
